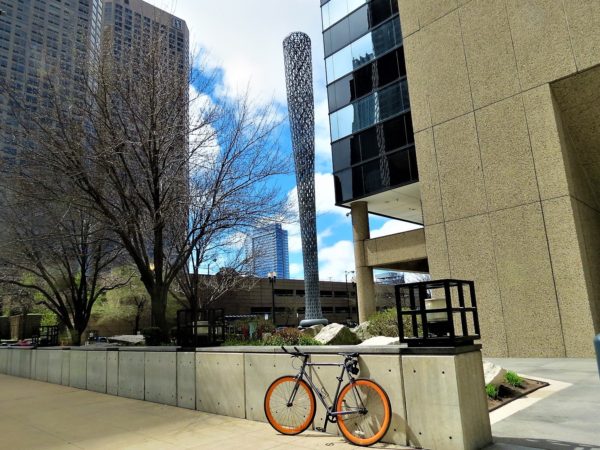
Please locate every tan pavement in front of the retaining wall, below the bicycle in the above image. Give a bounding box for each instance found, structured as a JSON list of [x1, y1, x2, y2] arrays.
[[0, 375, 406, 450]]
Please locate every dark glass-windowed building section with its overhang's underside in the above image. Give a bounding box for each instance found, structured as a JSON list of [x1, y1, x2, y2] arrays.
[[321, 0, 422, 223]]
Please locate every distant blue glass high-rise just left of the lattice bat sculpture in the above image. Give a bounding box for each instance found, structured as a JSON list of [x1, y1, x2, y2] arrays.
[[245, 223, 290, 279]]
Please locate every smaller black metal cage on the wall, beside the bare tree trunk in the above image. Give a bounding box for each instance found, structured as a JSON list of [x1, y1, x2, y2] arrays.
[[177, 308, 225, 347]]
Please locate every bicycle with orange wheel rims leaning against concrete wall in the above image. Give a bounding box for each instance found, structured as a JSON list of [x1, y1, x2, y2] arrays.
[[264, 346, 392, 446]]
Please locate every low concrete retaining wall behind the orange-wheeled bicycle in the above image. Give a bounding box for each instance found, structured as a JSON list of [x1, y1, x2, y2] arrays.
[[0, 346, 491, 450]]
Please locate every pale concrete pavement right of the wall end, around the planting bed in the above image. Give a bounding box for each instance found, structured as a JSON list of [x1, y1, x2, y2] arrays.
[[486, 358, 600, 450]]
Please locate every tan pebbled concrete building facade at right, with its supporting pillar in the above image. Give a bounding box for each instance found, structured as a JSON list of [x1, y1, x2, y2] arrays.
[[324, 0, 600, 357]]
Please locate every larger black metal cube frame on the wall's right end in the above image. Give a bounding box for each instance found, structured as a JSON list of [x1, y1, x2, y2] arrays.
[[395, 279, 481, 347]]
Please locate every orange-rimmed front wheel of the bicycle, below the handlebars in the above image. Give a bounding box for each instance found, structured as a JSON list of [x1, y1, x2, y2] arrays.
[[265, 375, 316, 435]]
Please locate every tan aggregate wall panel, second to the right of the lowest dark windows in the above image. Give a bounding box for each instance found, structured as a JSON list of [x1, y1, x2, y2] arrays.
[[434, 114, 487, 220]]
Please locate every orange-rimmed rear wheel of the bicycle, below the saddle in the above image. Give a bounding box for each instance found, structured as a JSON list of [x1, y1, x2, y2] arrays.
[[336, 380, 392, 446]]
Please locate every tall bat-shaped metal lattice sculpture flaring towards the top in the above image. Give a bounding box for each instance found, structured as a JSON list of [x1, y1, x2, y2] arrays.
[[283, 32, 327, 327]]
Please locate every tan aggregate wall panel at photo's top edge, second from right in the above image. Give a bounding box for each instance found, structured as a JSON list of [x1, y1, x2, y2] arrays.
[[506, 0, 576, 91]]
